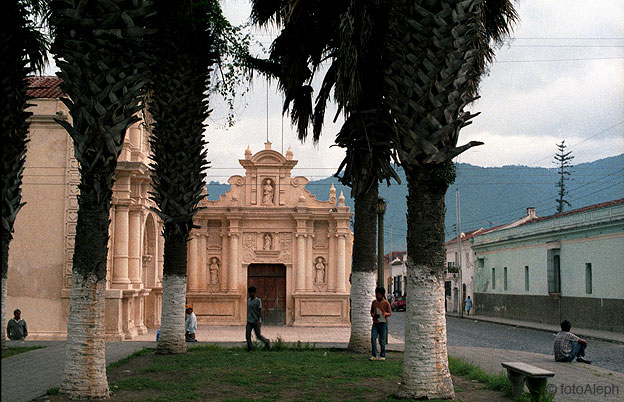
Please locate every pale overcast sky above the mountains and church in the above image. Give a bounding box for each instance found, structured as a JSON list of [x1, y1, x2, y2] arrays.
[[45, 0, 624, 182]]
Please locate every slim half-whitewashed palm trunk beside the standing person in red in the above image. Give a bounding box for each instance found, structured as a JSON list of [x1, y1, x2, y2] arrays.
[[348, 182, 378, 353]]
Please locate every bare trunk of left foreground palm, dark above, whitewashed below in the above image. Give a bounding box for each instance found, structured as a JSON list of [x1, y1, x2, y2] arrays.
[[61, 184, 112, 399]]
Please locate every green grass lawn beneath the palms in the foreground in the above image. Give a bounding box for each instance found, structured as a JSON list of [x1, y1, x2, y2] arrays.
[[38, 345, 510, 402]]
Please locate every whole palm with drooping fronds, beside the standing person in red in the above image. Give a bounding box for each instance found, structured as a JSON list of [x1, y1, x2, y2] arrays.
[[252, 0, 399, 352]]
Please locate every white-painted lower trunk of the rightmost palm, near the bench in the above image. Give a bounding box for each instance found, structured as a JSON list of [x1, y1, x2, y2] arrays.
[[397, 263, 455, 399]]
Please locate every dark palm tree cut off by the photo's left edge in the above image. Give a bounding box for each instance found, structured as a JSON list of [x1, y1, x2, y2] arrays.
[[0, 0, 48, 350]]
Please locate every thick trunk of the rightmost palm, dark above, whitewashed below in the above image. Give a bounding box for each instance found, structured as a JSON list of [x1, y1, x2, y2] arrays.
[[398, 164, 455, 399]]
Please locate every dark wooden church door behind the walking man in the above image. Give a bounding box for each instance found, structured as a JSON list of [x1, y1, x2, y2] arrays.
[[247, 264, 286, 325]]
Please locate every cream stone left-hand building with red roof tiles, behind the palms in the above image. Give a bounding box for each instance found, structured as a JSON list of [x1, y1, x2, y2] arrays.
[[7, 77, 164, 340]]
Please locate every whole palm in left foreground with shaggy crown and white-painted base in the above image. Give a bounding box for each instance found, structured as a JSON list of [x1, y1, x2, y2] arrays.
[[51, 0, 148, 398]]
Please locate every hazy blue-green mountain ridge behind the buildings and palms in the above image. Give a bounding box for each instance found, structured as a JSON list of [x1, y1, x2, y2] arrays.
[[207, 154, 624, 248]]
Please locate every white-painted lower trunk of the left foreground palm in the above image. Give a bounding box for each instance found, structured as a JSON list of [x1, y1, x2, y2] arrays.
[[60, 272, 110, 399]]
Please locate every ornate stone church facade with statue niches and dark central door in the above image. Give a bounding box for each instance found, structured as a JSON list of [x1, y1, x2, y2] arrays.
[[187, 142, 353, 326]]
